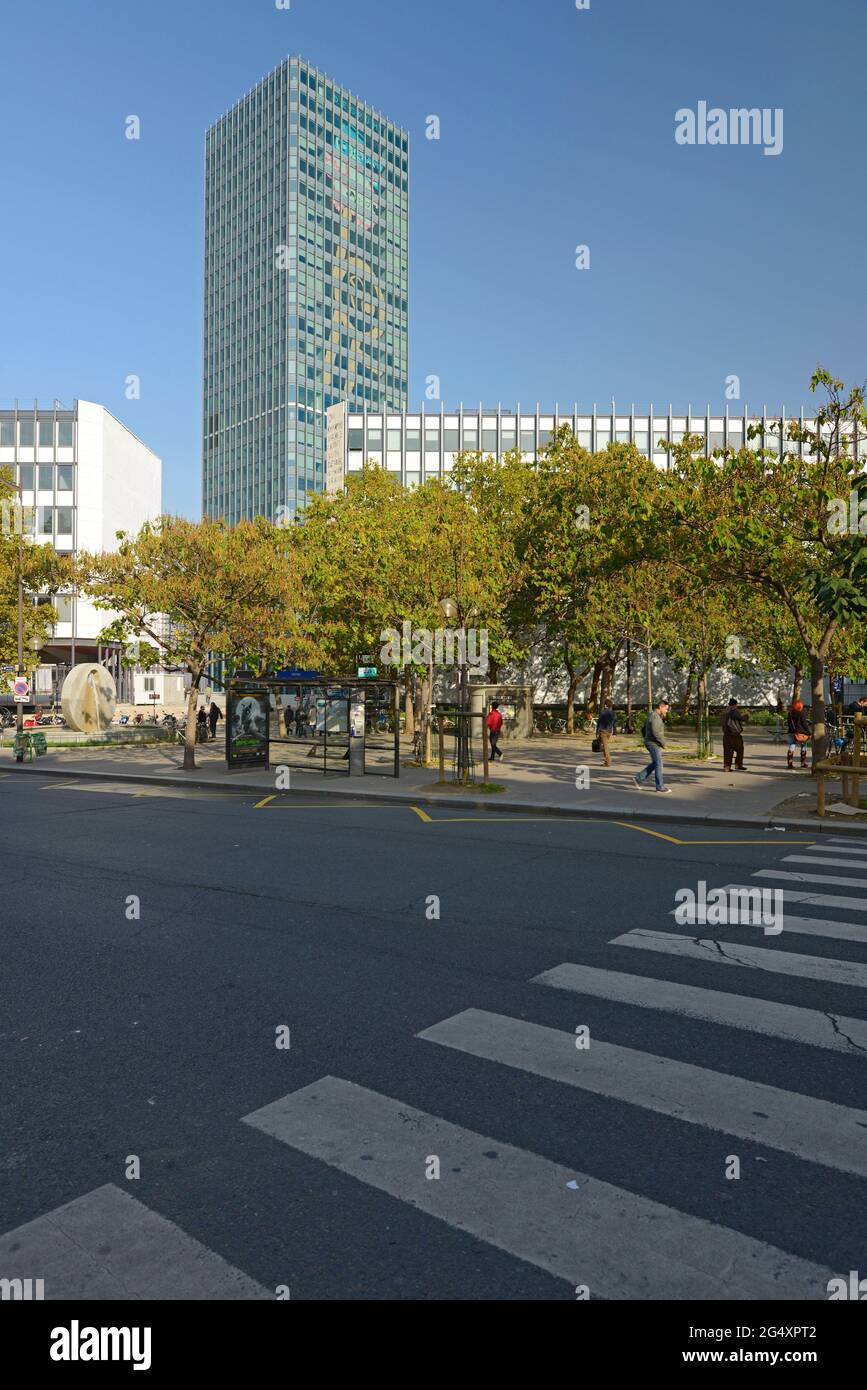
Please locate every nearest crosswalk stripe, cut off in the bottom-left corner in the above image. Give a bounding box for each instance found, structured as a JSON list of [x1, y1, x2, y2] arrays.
[[0, 1184, 274, 1301]]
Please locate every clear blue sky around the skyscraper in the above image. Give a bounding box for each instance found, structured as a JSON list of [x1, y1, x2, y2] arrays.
[[0, 0, 867, 516]]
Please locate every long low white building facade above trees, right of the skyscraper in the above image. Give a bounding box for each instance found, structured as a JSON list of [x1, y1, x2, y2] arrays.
[[327, 402, 867, 495]]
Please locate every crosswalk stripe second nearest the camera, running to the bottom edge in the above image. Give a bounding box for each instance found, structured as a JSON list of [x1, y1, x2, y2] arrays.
[[246, 1076, 831, 1300]]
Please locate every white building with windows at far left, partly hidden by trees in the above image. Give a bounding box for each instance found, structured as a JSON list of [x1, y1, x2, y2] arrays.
[[0, 400, 174, 701]]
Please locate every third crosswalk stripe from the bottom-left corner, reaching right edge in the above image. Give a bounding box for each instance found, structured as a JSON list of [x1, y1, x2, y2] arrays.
[[418, 1009, 867, 1177]]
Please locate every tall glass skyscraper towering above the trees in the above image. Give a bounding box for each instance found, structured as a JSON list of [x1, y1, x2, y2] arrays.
[[201, 57, 410, 523]]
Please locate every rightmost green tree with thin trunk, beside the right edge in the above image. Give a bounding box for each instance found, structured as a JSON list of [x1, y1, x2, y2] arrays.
[[647, 368, 867, 760]]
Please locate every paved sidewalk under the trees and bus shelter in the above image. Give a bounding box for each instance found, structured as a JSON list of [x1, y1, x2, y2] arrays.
[[0, 731, 867, 834]]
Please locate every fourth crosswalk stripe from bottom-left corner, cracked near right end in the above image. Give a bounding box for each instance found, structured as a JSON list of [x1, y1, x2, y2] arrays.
[[532, 962, 867, 1056]]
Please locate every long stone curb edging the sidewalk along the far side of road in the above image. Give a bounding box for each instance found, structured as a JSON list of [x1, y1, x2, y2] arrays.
[[7, 766, 867, 840]]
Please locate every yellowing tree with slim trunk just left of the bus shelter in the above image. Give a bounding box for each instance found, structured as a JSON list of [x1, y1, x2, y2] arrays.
[[78, 517, 314, 771]]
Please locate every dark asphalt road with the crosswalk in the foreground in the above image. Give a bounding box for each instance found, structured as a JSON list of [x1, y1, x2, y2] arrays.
[[0, 776, 867, 1300]]
